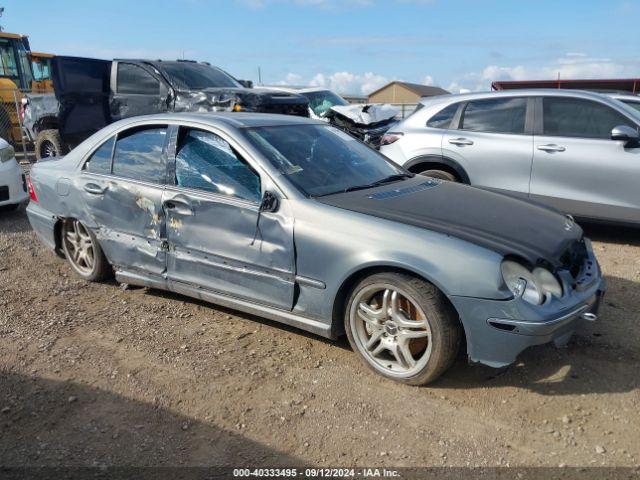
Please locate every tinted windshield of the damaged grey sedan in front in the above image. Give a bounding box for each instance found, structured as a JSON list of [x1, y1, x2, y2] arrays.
[[245, 125, 413, 197]]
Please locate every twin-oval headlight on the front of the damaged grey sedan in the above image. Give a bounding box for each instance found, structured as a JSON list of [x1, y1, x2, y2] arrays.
[[501, 260, 562, 305]]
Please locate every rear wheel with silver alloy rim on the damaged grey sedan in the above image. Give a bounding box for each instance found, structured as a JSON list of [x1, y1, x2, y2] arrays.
[[62, 219, 111, 282]]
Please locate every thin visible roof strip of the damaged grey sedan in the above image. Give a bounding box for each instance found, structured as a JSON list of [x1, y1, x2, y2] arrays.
[[110, 112, 326, 128]]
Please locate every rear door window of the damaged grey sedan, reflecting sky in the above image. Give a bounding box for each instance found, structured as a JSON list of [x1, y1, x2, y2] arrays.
[[113, 127, 167, 184]]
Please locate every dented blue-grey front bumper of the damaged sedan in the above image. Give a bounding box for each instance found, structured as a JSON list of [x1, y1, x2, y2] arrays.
[[450, 242, 605, 368]]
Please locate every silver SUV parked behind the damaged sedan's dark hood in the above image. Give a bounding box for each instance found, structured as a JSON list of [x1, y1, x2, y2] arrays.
[[380, 89, 640, 226]]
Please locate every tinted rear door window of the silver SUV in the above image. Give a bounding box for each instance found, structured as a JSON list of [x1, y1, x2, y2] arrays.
[[461, 98, 527, 134]]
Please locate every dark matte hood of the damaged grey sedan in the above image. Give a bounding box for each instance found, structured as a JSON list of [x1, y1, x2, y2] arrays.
[[317, 175, 583, 267]]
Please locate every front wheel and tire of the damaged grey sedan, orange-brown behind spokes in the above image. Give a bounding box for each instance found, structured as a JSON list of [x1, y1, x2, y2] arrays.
[[344, 272, 462, 385]]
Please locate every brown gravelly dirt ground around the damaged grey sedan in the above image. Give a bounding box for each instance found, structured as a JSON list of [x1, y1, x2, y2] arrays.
[[0, 203, 640, 467]]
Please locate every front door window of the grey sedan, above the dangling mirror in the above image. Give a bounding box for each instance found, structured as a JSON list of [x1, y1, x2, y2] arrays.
[[176, 130, 261, 203]]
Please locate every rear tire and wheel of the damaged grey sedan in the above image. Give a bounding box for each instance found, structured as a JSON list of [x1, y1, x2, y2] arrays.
[[60, 219, 113, 282]]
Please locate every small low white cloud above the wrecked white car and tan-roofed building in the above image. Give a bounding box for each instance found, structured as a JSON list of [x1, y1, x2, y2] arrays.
[[277, 72, 391, 95]]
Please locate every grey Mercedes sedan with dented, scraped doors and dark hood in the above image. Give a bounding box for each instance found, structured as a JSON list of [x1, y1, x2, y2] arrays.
[[27, 113, 603, 384]]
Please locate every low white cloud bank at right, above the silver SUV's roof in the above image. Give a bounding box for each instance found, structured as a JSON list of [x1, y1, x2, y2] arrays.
[[448, 52, 640, 92]]
